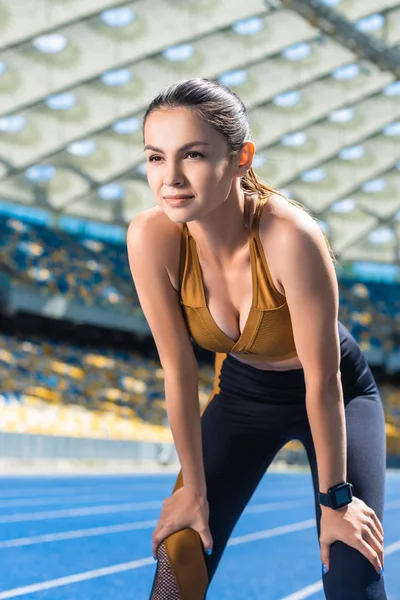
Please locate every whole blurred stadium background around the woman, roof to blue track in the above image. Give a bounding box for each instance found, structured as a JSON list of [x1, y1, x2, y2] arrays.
[[0, 0, 400, 600]]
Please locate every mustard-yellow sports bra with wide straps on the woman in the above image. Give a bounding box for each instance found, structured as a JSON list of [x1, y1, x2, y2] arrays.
[[179, 202, 297, 361]]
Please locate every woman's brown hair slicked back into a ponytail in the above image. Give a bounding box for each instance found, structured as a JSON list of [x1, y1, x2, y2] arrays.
[[143, 78, 336, 262]]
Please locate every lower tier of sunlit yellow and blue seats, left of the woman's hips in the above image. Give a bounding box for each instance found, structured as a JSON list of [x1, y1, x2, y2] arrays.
[[0, 334, 213, 441]]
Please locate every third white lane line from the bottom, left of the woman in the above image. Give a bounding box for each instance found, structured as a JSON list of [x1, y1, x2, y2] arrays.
[[0, 501, 161, 523]]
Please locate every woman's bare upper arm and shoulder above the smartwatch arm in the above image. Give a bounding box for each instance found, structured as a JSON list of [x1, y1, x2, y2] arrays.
[[277, 213, 340, 386]]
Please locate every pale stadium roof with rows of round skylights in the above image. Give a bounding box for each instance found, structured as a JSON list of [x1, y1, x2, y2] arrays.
[[0, 0, 400, 262]]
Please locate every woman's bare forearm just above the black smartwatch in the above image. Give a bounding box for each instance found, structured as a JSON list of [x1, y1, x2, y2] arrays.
[[306, 372, 347, 493]]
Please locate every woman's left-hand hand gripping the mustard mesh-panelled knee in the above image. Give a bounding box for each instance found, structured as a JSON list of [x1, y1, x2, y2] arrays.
[[152, 486, 213, 559]]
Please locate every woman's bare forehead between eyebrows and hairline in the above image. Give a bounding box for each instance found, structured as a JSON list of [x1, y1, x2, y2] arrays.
[[144, 108, 226, 148]]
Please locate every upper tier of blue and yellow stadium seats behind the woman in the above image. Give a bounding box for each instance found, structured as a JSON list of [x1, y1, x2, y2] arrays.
[[0, 216, 400, 352]]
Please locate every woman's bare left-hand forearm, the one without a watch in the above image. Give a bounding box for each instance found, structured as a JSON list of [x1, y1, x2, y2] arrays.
[[165, 367, 206, 497]]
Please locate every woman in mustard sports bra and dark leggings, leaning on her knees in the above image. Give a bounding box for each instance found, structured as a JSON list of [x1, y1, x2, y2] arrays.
[[127, 79, 386, 600]]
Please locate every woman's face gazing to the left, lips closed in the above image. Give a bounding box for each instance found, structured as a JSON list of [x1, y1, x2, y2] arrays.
[[144, 108, 237, 223]]
